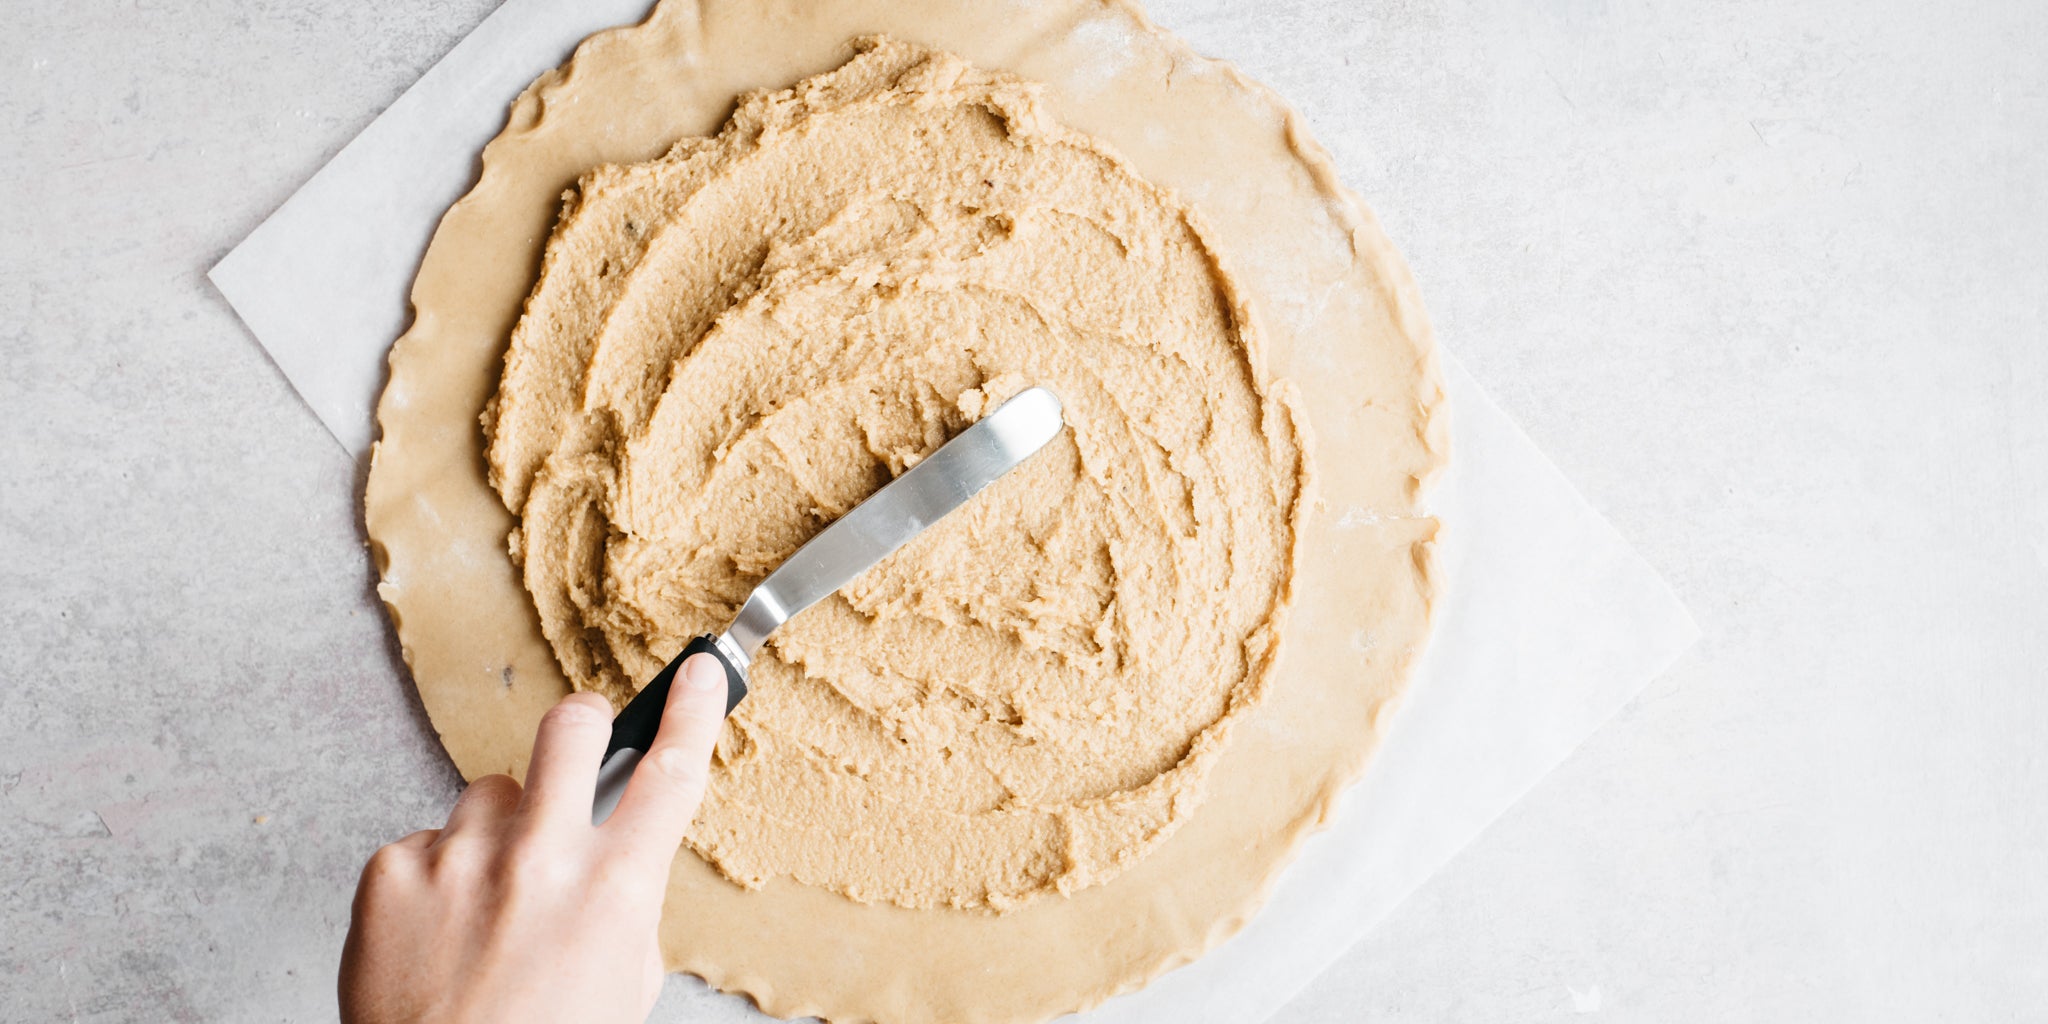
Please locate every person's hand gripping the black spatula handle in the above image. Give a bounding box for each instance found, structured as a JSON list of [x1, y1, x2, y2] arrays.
[[340, 653, 725, 1024]]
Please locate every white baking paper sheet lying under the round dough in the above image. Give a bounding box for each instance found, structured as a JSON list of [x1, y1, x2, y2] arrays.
[[211, 0, 1698, 1024]]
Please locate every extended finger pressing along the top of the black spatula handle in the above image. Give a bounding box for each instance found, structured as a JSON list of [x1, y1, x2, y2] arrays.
[[604, 653, 725, 864]]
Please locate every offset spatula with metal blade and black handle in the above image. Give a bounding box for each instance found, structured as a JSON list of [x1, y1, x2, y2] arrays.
[[592, 387, 1063, 821]]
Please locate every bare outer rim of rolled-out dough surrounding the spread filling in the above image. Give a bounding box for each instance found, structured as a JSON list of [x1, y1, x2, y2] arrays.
[[367, 0, 1446, 1022]]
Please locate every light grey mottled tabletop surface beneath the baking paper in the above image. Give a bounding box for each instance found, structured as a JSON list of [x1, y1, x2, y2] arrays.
[[0, 0, 2048, 1024]]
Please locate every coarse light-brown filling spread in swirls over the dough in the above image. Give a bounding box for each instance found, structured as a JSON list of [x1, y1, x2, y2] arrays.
[[485, 39, 1307, 911]]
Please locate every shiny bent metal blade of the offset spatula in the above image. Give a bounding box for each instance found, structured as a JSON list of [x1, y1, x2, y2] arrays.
[[725, 387, 1065, 668]]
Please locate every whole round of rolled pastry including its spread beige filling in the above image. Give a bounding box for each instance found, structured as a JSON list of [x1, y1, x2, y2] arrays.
[[365, 0, 1446, 1024]]
